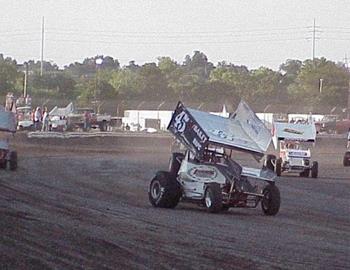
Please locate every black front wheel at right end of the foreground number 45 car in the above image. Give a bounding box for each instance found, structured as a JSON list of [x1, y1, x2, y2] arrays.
[[261, 184, 281, 216]]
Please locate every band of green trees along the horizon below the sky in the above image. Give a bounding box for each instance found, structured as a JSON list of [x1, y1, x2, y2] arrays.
[[0, 51, 349, 107]]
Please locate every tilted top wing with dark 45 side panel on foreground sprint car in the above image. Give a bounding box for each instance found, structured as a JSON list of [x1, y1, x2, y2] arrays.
[[168, 101, 271, 158]]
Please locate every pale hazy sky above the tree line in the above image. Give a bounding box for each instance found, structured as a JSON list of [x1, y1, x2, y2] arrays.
[[0, 0, 350, 70]]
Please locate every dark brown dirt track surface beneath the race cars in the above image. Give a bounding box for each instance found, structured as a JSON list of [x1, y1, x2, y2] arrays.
[[0, 136, 350, 269]]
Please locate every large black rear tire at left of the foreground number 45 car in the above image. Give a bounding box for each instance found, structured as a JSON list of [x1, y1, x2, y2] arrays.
[[148, 171, 181, 208]]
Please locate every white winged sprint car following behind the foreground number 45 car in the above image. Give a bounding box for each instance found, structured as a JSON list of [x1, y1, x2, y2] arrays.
[[265, 121, 318, 178]]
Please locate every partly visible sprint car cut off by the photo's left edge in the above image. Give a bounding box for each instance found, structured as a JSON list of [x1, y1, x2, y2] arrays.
[[0, 107, 17, 171]]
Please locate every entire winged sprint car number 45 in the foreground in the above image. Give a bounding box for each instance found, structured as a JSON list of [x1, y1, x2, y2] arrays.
[[148, 101, 280, 215]]
